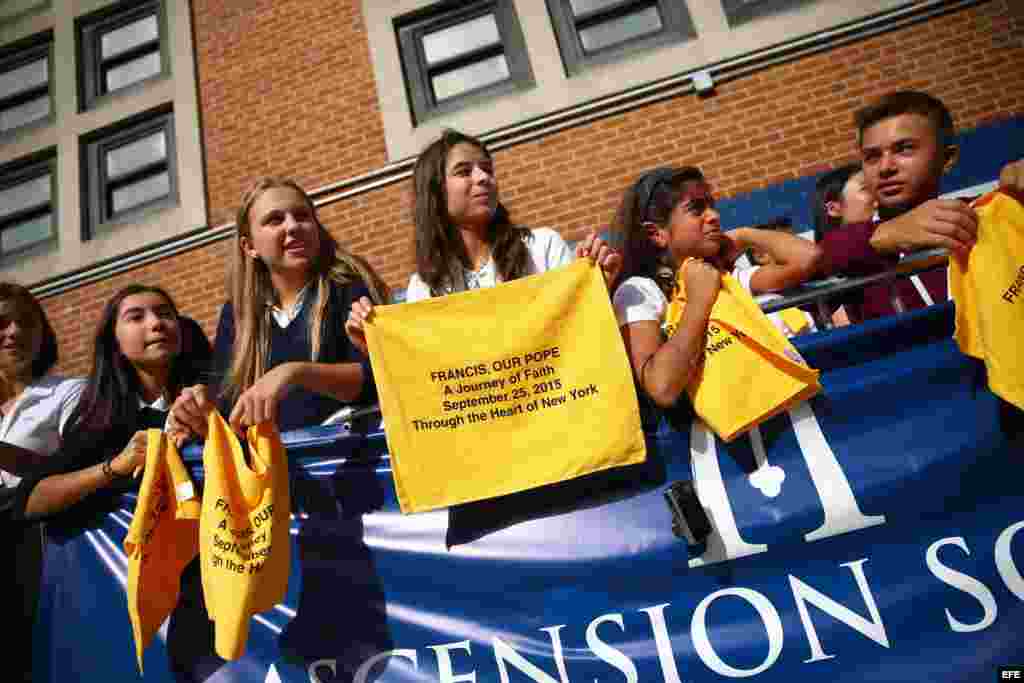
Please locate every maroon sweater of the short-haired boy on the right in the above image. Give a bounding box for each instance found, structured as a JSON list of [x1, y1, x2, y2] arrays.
[[820, 221, 948, 323]]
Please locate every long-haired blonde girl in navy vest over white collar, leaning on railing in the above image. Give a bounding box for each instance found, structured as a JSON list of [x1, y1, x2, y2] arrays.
[[169, 177, 388, 445]]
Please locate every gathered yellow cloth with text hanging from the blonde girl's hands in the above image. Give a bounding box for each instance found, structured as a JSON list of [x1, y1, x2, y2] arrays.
[[199, 411, 292, 659]]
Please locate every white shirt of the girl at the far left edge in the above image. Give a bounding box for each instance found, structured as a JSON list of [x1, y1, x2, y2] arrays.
[[0, 376, 85, 486]]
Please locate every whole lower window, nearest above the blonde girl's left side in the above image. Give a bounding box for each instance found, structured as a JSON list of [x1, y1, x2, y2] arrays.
[[82, 108, 177, 240]]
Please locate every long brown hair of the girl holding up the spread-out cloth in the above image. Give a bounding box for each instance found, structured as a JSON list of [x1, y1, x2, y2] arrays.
[[413, 130, 529, 296]]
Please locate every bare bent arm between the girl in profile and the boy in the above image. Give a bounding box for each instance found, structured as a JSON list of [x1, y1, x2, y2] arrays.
[[727, 227, 822, 294]]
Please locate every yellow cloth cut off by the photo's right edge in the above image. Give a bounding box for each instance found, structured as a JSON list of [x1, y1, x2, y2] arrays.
[[949, 189, 1024, 409]]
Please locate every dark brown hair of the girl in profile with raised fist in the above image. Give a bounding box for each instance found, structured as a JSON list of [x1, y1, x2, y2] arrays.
[[613, 166, 705, 299]]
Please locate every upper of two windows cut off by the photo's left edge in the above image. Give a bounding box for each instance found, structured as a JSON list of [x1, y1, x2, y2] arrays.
[[0, 34, 53, 135]]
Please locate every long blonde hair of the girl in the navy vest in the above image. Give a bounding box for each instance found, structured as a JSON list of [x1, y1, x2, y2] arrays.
[[221, 176, 389, 401]]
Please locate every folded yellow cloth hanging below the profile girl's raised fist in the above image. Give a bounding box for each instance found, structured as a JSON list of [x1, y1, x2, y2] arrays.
[[665, 263, 821, 441]]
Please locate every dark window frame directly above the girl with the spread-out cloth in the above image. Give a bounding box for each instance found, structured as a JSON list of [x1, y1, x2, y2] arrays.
[[393, 0, 534, 125]]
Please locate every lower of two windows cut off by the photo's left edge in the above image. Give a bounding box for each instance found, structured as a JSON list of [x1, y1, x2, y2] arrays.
[[0, 151, 56, 257]]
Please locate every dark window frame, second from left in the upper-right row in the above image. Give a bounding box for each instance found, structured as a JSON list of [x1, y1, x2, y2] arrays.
[[547, 0, 696, 77]]
